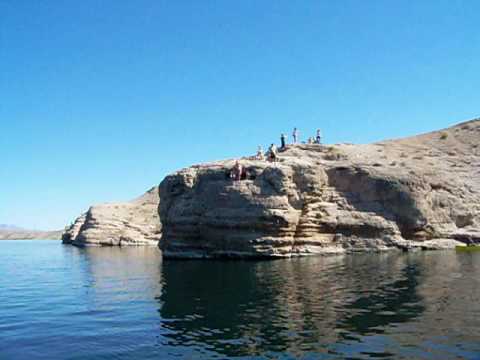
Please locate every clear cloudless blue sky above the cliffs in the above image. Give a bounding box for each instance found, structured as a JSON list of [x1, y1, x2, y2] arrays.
[[0, 0, 480, 229]]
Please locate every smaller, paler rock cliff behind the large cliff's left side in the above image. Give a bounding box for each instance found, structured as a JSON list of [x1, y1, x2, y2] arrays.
[[62, 187, 161, 246]]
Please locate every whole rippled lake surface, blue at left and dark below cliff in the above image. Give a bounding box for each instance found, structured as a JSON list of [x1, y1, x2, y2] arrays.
[[0, 241, 480, 360]]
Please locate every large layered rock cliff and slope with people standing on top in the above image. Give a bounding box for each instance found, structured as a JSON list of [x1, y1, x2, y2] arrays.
[[159, 120, 480, 257]]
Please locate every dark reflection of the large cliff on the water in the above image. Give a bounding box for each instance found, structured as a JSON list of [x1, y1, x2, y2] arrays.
[[160, 254, 424, 356]]
